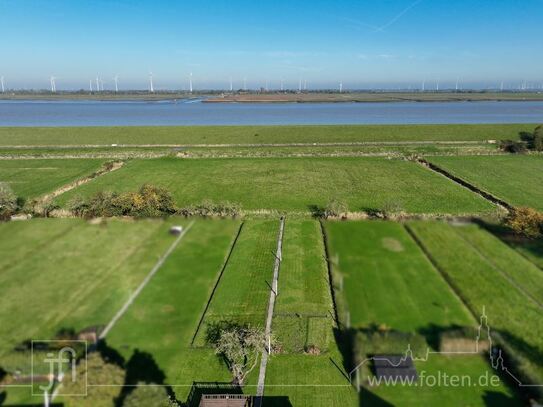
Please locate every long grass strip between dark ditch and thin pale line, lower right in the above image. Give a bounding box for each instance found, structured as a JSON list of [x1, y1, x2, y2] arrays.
[[409, 222, 543, 383]]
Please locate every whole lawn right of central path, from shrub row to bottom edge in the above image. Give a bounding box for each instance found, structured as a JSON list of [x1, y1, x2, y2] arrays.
[[265, 220, 358, 407]]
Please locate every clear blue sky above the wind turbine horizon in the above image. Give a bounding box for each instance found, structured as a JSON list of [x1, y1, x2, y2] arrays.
[[0, 0, 543, 89]]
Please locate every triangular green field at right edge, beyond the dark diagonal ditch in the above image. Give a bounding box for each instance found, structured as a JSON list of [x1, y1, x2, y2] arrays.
[[429, 155, 543, 210]]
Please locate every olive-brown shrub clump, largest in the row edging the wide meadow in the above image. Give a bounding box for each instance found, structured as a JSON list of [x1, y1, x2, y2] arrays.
[[68, 184, 177, 218]]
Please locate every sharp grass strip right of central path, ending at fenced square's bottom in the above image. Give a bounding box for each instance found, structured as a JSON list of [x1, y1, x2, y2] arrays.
[[272, 220, 334, 352]]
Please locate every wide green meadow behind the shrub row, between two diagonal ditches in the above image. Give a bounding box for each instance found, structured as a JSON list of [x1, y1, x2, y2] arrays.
[[58, 157, 494, 214]]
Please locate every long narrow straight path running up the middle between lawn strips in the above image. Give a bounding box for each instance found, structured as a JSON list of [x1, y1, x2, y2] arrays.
[[256, 216, 285, 407]]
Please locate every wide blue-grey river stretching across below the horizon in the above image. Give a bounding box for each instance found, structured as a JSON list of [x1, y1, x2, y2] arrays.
[[0, 100, 543, 126]]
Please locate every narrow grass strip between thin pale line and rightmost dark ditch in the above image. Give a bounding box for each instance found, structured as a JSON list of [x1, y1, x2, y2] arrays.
[[454, 225, 543, 304]]
